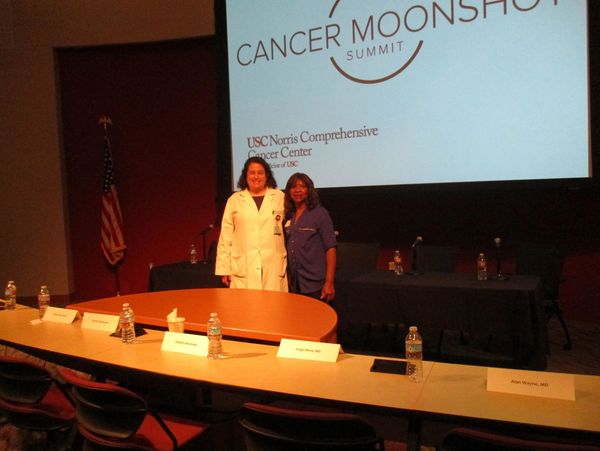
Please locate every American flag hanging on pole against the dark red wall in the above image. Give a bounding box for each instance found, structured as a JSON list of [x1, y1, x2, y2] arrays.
[[100, 136, 127, 265]]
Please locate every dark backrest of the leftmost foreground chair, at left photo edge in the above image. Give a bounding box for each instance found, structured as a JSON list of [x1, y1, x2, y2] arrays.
[[0, 356, 52, 404]]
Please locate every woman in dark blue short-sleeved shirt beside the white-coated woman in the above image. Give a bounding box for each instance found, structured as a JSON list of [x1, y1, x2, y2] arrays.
[[284, 173, 336, 302]]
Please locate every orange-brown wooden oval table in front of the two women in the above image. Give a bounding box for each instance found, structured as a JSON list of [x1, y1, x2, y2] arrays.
[[67, 288, 337, 343]]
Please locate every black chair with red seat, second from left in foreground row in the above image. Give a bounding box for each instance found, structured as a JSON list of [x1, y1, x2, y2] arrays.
[[60, 369, 208, 451]]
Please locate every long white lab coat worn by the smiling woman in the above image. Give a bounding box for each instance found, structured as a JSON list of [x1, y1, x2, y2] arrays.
[[215, 188, 288, 291]]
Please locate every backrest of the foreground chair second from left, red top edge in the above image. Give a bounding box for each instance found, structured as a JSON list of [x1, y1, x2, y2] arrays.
[[60, 369, 148, 439]]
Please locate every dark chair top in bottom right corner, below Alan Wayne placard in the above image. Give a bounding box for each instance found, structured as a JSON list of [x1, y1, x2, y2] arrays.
[[440, 427, 600, 451]]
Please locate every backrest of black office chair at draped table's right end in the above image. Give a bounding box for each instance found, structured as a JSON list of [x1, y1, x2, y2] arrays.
[[515, 243, 565, 299]]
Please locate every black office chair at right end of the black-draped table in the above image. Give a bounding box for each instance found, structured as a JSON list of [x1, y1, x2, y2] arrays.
[[516, 243, 572, 351]]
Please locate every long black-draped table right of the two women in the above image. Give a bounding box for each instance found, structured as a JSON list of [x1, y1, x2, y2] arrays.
[[336, 271, 548, 370]]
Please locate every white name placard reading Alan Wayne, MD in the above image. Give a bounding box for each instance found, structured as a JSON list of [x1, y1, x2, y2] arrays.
[[487, 368, 575, 401]]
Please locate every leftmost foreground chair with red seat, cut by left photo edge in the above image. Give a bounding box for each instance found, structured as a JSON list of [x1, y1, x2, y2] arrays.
[[0, 356, 75, 443]]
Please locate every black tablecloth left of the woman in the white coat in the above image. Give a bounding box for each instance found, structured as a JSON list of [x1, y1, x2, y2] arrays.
[[148, 261, 223, 291]]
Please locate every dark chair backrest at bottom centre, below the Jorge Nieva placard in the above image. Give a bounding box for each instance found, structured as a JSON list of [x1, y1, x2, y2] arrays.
[[240, 403, 383, 451]]
